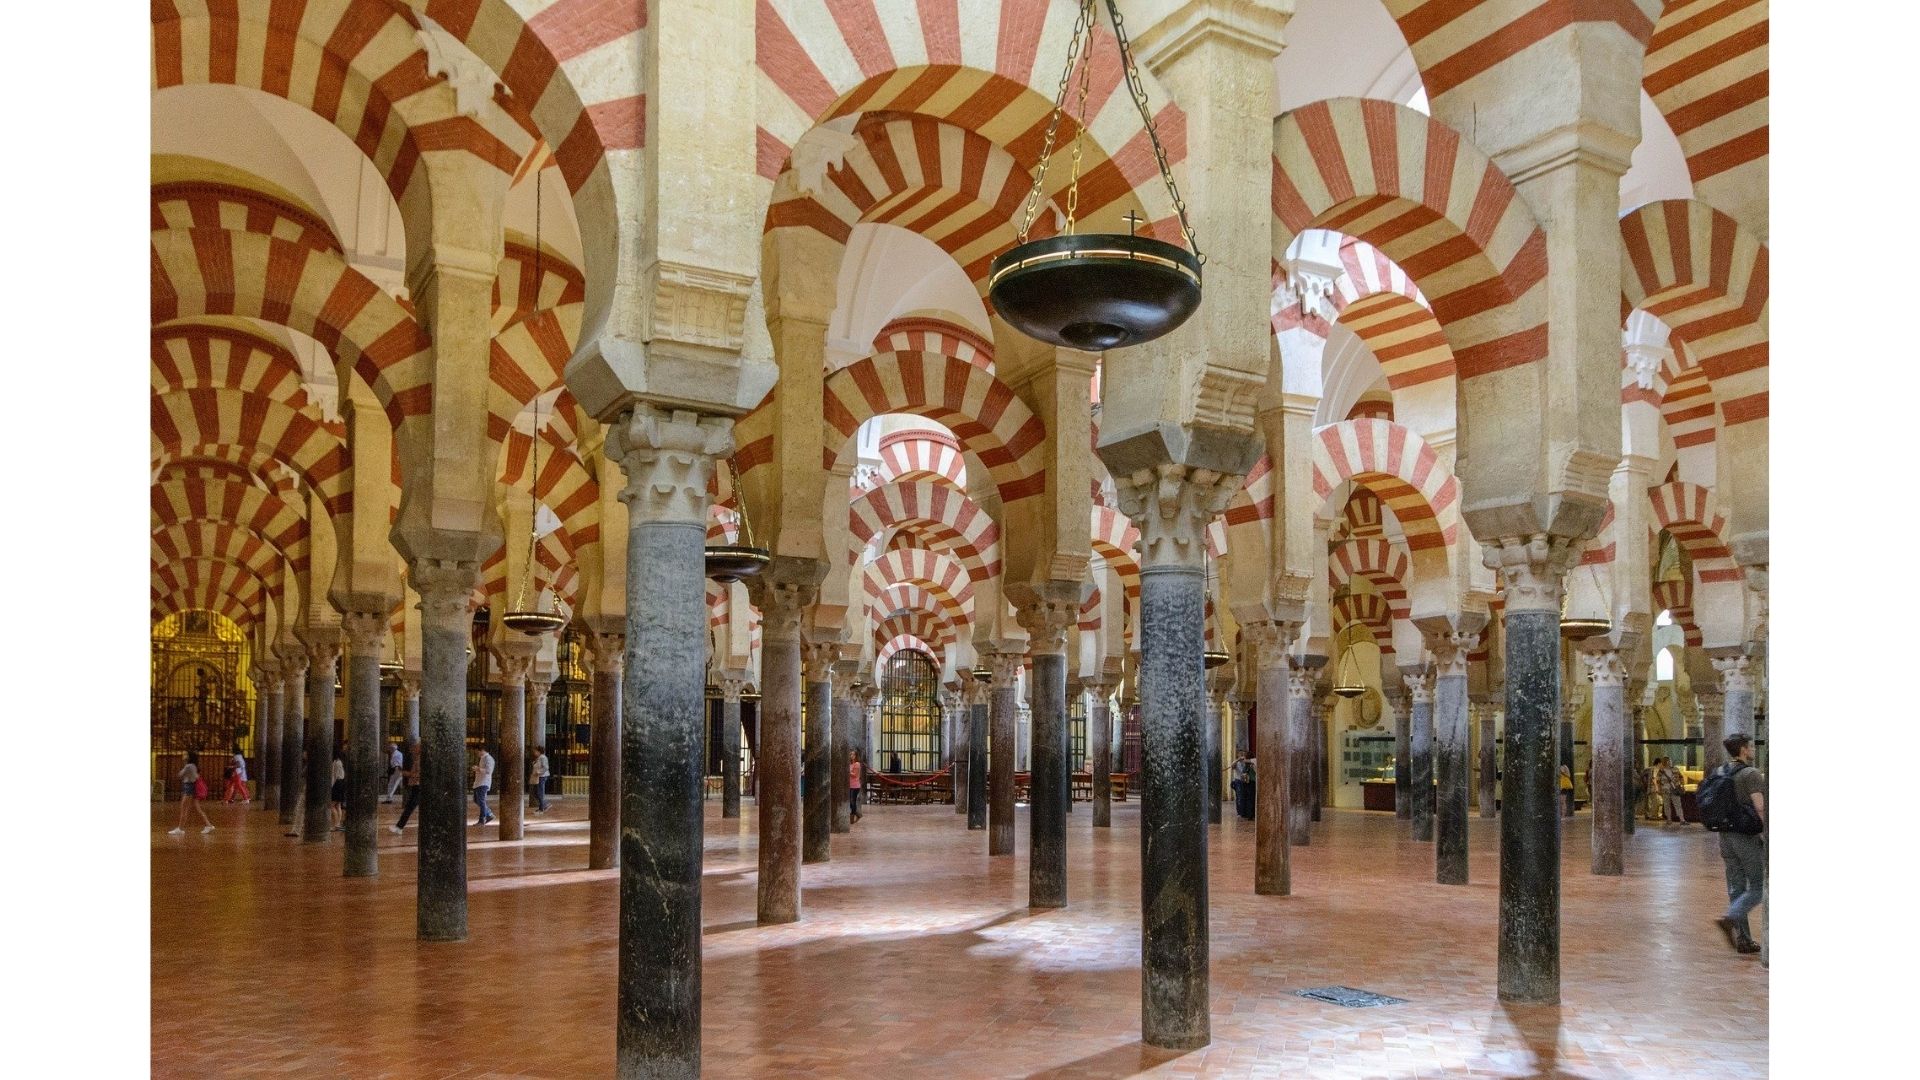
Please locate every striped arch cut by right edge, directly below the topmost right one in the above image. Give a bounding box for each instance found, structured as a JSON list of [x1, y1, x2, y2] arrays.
[[1620, 200, 1768, 425]]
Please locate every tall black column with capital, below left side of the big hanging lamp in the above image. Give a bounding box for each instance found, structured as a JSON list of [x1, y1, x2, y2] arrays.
[[1020, 582, 1079, 909]]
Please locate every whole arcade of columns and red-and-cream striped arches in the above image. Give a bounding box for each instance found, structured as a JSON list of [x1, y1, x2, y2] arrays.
[[152, 0, 1768, 1076]]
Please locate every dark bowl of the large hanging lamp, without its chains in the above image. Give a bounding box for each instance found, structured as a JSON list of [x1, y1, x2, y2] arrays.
[[987, 233, 1200, 352]]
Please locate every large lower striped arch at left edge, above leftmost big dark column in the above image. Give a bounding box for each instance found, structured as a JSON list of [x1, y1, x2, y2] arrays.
[[150, 229, 434, 429]]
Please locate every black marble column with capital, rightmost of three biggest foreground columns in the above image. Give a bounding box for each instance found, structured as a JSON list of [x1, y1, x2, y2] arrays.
[[1482, 534, 1578, 1005]]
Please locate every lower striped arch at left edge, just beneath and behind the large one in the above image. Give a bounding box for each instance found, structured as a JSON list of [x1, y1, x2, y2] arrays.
[[150, 390, 351, 515]]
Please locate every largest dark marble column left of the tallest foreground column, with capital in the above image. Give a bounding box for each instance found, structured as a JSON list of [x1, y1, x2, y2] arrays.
[[407, 559, 480, 942]]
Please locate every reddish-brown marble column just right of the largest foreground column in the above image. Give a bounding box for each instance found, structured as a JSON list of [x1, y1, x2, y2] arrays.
[[751, 557, 826, 926]]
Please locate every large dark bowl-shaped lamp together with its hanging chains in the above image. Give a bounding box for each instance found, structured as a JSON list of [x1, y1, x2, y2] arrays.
[[987, 0, 1206, 352]]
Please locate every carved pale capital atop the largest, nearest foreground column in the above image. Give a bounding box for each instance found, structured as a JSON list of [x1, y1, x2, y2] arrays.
[[607, 404, 733, 525]]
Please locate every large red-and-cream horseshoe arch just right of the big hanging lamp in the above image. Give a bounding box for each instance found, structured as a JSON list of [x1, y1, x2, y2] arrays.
[[1273, 98, 1548, 379]]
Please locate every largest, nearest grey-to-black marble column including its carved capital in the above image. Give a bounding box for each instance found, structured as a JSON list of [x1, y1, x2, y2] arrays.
[[607, 404, 733, 1076]]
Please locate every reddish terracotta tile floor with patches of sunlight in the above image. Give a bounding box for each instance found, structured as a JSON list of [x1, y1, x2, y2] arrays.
[[152, 799, 1766, 1080]]
